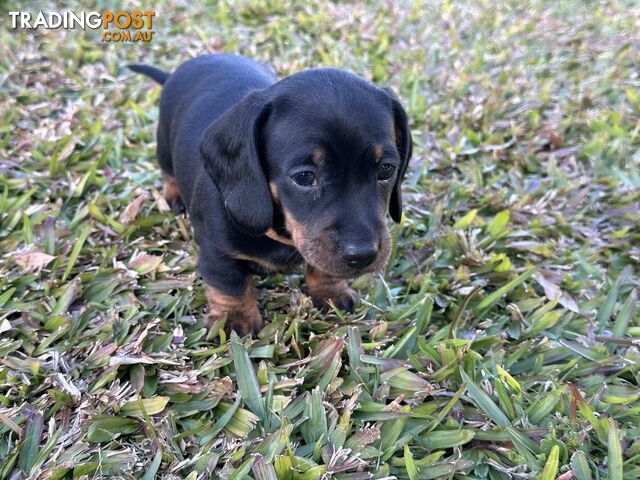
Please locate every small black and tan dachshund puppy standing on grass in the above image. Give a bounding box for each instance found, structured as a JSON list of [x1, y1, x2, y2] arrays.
[[130, 55, 412, 335]]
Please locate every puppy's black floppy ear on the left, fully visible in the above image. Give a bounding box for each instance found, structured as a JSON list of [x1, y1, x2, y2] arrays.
[[200, 90, 273, 235]]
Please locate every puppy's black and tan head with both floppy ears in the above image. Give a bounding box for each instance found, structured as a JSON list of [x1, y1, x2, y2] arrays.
[[201, 69, 412, 278]]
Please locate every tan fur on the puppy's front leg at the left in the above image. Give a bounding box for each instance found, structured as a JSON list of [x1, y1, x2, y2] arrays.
[[204, 279, 263, 336]]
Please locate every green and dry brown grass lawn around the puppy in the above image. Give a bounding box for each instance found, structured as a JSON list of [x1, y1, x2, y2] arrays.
[[0, 0, 640, 480]]
